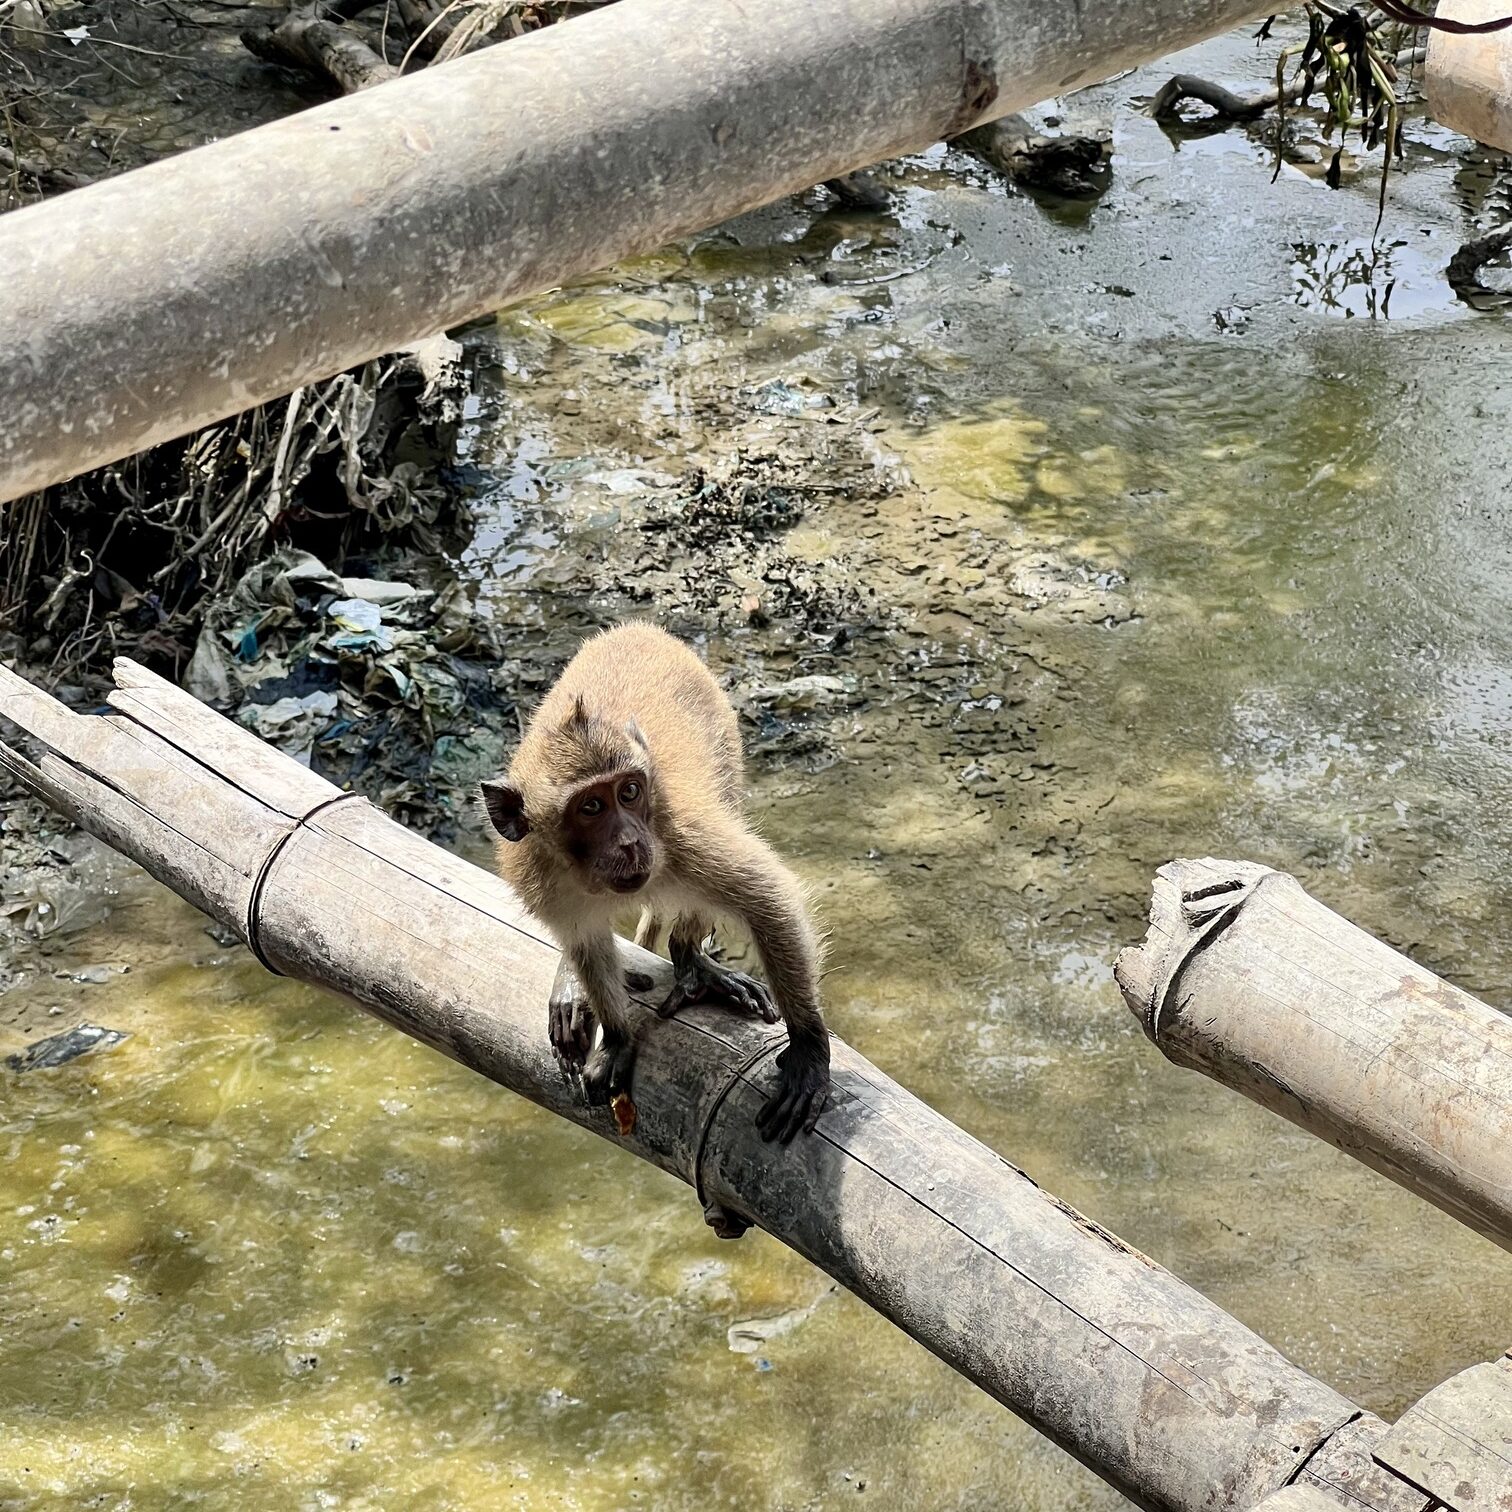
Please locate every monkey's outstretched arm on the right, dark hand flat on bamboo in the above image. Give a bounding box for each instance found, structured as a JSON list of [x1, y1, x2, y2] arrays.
[[699, 830, 830, 1145]]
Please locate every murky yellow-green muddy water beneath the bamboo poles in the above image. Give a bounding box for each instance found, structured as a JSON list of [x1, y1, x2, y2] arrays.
[[0, 26, 1512, 1512]]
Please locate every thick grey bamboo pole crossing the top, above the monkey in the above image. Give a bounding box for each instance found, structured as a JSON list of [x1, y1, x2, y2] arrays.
[[0, 0, 1288, 502]]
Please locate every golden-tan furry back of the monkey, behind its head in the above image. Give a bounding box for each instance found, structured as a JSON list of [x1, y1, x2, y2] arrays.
[[532, 621, 744, 810]]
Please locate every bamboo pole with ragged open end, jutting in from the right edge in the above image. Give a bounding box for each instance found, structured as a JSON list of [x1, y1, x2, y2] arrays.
[[1114, 860, 1512, 1249]]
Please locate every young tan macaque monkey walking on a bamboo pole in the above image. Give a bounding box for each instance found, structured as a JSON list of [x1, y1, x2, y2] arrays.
[[484, 624, 830, 1143]]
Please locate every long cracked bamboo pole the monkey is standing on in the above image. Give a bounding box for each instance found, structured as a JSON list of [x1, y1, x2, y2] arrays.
[[0, 661, 1426, 1512]]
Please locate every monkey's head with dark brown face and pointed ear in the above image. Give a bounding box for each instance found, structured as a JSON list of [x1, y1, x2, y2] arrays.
[[482, 699, 661, 895]]
